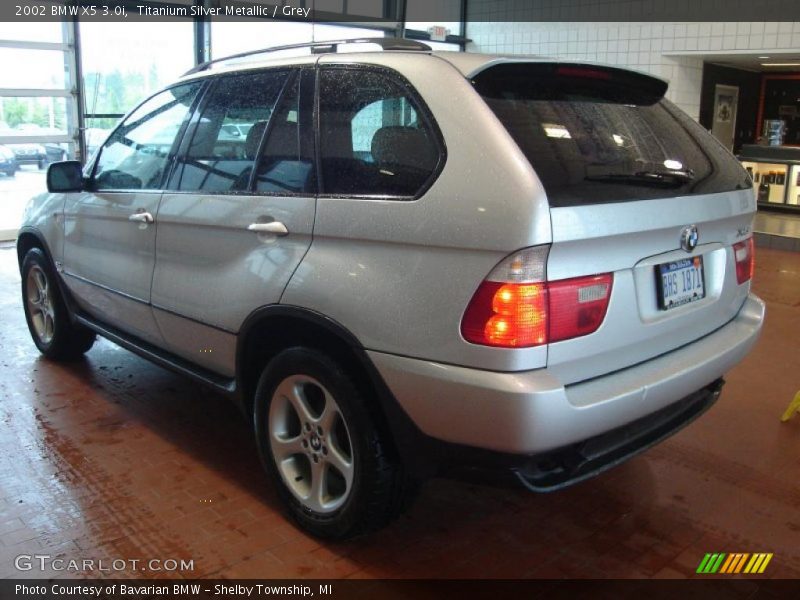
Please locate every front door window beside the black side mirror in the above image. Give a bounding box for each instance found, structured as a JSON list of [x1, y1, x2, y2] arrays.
[[94, 82, 202, 190]]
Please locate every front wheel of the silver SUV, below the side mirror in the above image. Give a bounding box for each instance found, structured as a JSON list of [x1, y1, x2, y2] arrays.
[[22, 248, 96, 360]]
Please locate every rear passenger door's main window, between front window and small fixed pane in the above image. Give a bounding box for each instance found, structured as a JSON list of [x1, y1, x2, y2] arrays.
[[167, 71, 288, 193]]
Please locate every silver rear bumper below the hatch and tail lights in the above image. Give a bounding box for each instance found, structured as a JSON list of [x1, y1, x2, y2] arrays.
[[369, 294, 764, 456]]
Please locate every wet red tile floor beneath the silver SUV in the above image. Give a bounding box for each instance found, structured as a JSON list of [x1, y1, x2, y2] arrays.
[[0, 241, 800, 578]]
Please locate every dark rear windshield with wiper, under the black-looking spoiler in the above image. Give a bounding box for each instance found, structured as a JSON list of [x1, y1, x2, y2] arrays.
[[472, 63, 750, 206]]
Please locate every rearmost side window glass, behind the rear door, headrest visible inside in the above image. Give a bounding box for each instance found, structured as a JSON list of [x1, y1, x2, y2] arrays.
[[320, 68, 440, 196]]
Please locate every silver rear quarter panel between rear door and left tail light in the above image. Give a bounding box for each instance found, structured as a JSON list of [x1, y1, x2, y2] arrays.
[[281, 53, 551, 370]]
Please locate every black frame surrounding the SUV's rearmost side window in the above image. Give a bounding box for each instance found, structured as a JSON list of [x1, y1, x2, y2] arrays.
[[314, 63, 447, 202]]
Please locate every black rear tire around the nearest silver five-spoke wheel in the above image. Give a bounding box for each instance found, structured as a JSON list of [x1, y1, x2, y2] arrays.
[[253, 347, 413, 540]]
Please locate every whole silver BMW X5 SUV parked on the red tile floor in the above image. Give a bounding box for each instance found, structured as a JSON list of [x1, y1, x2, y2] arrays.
[[17, 39, 764, 538]]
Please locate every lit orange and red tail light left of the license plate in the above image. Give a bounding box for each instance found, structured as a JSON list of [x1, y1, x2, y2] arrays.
[[461, 246, 613, 348]]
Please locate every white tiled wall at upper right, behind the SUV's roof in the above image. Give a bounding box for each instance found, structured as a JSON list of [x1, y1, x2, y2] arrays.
[[466, 20, 800, 119]]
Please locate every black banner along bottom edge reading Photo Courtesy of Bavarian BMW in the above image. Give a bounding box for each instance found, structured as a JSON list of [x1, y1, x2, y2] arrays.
[[0, 576, 800, 600]]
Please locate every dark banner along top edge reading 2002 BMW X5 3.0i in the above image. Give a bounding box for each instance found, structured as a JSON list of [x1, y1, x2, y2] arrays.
[[0, 0, 800, 26]]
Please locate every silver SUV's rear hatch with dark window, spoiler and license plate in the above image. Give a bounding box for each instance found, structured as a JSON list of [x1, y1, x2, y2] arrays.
[[471, 61, 755, 384]]
